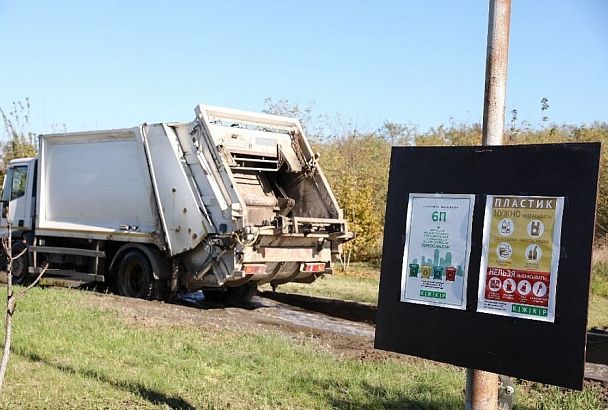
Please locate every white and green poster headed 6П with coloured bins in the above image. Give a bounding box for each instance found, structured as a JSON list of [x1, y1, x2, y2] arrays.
[[401, 194, 475, 309]]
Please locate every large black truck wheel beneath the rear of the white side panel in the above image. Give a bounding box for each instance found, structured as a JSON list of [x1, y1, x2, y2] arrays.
[[116, 250, 154, 299]]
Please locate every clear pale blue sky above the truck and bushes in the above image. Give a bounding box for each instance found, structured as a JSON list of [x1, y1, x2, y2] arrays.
[[0, 0, 608, 133]]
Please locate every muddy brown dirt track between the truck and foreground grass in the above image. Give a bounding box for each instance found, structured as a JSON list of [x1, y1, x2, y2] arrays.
[[82, 293, 404, 361]]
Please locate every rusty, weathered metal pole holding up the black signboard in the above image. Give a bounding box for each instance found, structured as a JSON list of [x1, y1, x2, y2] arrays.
[[465, 0, 511, 410]]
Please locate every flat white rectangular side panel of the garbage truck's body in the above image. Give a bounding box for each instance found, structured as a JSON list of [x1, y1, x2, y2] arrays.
[[36, 128, 164, 244]]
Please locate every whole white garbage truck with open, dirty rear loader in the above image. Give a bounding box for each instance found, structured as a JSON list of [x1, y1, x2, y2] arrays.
[[0, 105, 353, 303]]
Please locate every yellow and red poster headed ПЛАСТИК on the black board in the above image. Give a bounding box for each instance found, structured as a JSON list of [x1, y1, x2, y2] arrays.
[[477, 195, 564, 322]]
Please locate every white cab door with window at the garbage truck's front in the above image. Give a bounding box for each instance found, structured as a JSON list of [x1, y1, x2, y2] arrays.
[[0, 163, 33, 231]]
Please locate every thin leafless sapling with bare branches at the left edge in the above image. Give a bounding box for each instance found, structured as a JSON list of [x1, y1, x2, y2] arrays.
[[0, 220, 48, 390]]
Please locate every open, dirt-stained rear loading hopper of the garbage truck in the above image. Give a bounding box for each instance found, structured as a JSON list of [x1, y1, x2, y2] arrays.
[[177, 106, 352, 290]]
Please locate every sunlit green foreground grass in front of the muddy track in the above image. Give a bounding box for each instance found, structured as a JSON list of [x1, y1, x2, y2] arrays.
[[0, 288, 608, 409]]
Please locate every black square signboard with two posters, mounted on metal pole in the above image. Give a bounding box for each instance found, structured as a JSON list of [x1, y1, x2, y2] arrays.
[[375, 143, 600, 389]]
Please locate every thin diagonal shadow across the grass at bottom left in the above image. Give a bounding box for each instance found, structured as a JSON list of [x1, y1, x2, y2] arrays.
[[15, 351, 196, 410]]
